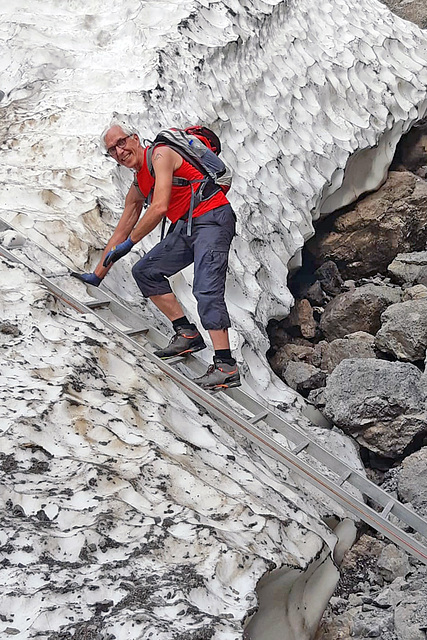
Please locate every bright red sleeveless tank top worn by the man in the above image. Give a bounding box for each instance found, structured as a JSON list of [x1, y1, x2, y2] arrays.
[[136, 149, 229, 222]]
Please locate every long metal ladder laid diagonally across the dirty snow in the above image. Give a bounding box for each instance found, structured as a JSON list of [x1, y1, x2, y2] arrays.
[[0, 218, 427, 564]]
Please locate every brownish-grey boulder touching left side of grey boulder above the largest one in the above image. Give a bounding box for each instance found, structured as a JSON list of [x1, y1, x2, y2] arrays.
[[320, 284, 401, 341]]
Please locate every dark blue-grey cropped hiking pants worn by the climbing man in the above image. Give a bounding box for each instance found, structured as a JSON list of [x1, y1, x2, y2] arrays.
[[132, 205, 235, 330]]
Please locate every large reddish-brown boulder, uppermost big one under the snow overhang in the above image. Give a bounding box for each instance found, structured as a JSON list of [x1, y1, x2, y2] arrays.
[[306, 171, 427, 279]]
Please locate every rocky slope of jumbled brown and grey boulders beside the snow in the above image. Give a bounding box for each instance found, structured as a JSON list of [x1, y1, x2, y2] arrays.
[[270, 50, 427, 640]]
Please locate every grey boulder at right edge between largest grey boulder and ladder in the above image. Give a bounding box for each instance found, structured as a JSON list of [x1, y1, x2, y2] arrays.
[[397, 447, 427, 518]]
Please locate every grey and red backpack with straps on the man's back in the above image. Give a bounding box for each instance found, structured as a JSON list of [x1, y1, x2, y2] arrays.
[[146, 126, 232, 240]]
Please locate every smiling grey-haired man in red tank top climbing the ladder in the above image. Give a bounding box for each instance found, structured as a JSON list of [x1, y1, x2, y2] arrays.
[[75, 125, 240, 389]]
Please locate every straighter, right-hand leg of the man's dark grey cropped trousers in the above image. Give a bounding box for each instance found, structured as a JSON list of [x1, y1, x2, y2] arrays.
[[193, 206, 235, 330]]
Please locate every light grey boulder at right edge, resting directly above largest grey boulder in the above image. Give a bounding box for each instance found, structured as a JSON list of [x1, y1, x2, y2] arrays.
[[375, 298, 427, 362]]
